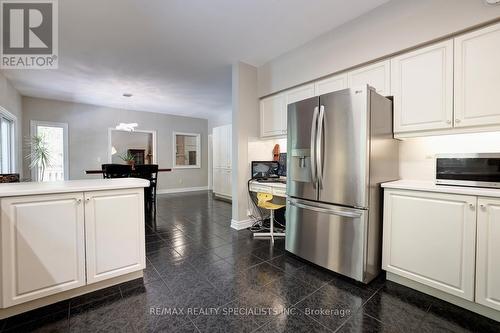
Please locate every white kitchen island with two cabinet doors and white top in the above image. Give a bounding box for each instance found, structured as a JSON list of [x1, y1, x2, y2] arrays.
[[0, 178, 149, 319]]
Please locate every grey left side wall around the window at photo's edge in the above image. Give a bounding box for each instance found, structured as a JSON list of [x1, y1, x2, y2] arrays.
[[0, 73, 23, 176]]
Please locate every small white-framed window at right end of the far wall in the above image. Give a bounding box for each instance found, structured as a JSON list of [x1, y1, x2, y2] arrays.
[[174, 132, 201, 169]]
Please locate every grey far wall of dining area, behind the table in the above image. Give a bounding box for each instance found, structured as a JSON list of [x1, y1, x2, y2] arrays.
[[23, 97, 208, 190]]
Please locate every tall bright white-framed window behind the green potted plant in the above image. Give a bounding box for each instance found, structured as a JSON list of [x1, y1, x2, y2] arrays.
[[31, 121, 69, 182]]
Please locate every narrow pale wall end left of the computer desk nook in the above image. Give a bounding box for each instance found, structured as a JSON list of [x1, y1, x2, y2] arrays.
[[232, 62, 260, 227]]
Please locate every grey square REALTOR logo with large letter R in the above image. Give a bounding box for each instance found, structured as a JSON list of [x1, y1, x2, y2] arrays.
[[0, 0, 58, 69]]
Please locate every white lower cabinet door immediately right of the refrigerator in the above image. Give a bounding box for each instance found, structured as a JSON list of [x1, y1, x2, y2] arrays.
[[382, 190, 476, 301]]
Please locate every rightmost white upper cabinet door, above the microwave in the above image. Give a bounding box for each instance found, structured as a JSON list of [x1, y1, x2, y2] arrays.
[[455, 24, 500, 127]]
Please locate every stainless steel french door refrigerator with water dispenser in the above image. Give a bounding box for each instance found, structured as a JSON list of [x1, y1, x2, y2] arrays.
[[285, 86, 398, 283]]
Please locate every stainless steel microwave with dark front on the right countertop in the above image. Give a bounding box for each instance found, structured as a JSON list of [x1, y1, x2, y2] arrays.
[[436, 153, 500, 188]]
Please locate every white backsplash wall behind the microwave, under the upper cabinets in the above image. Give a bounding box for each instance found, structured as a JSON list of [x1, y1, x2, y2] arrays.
[[399, 132, 500, 180]]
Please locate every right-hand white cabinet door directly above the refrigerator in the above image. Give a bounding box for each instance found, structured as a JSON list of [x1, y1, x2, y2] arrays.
[[347, 60, 391, 96]]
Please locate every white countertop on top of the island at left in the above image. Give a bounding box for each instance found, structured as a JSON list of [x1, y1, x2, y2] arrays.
[[0, 178, 149, 198]]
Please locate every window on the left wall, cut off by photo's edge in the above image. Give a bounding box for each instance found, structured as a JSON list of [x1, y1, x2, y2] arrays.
[[0, 108, 17, 174]]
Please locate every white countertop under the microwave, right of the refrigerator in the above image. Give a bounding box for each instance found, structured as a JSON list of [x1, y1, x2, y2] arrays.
[[382, 180, 500, 197]]
